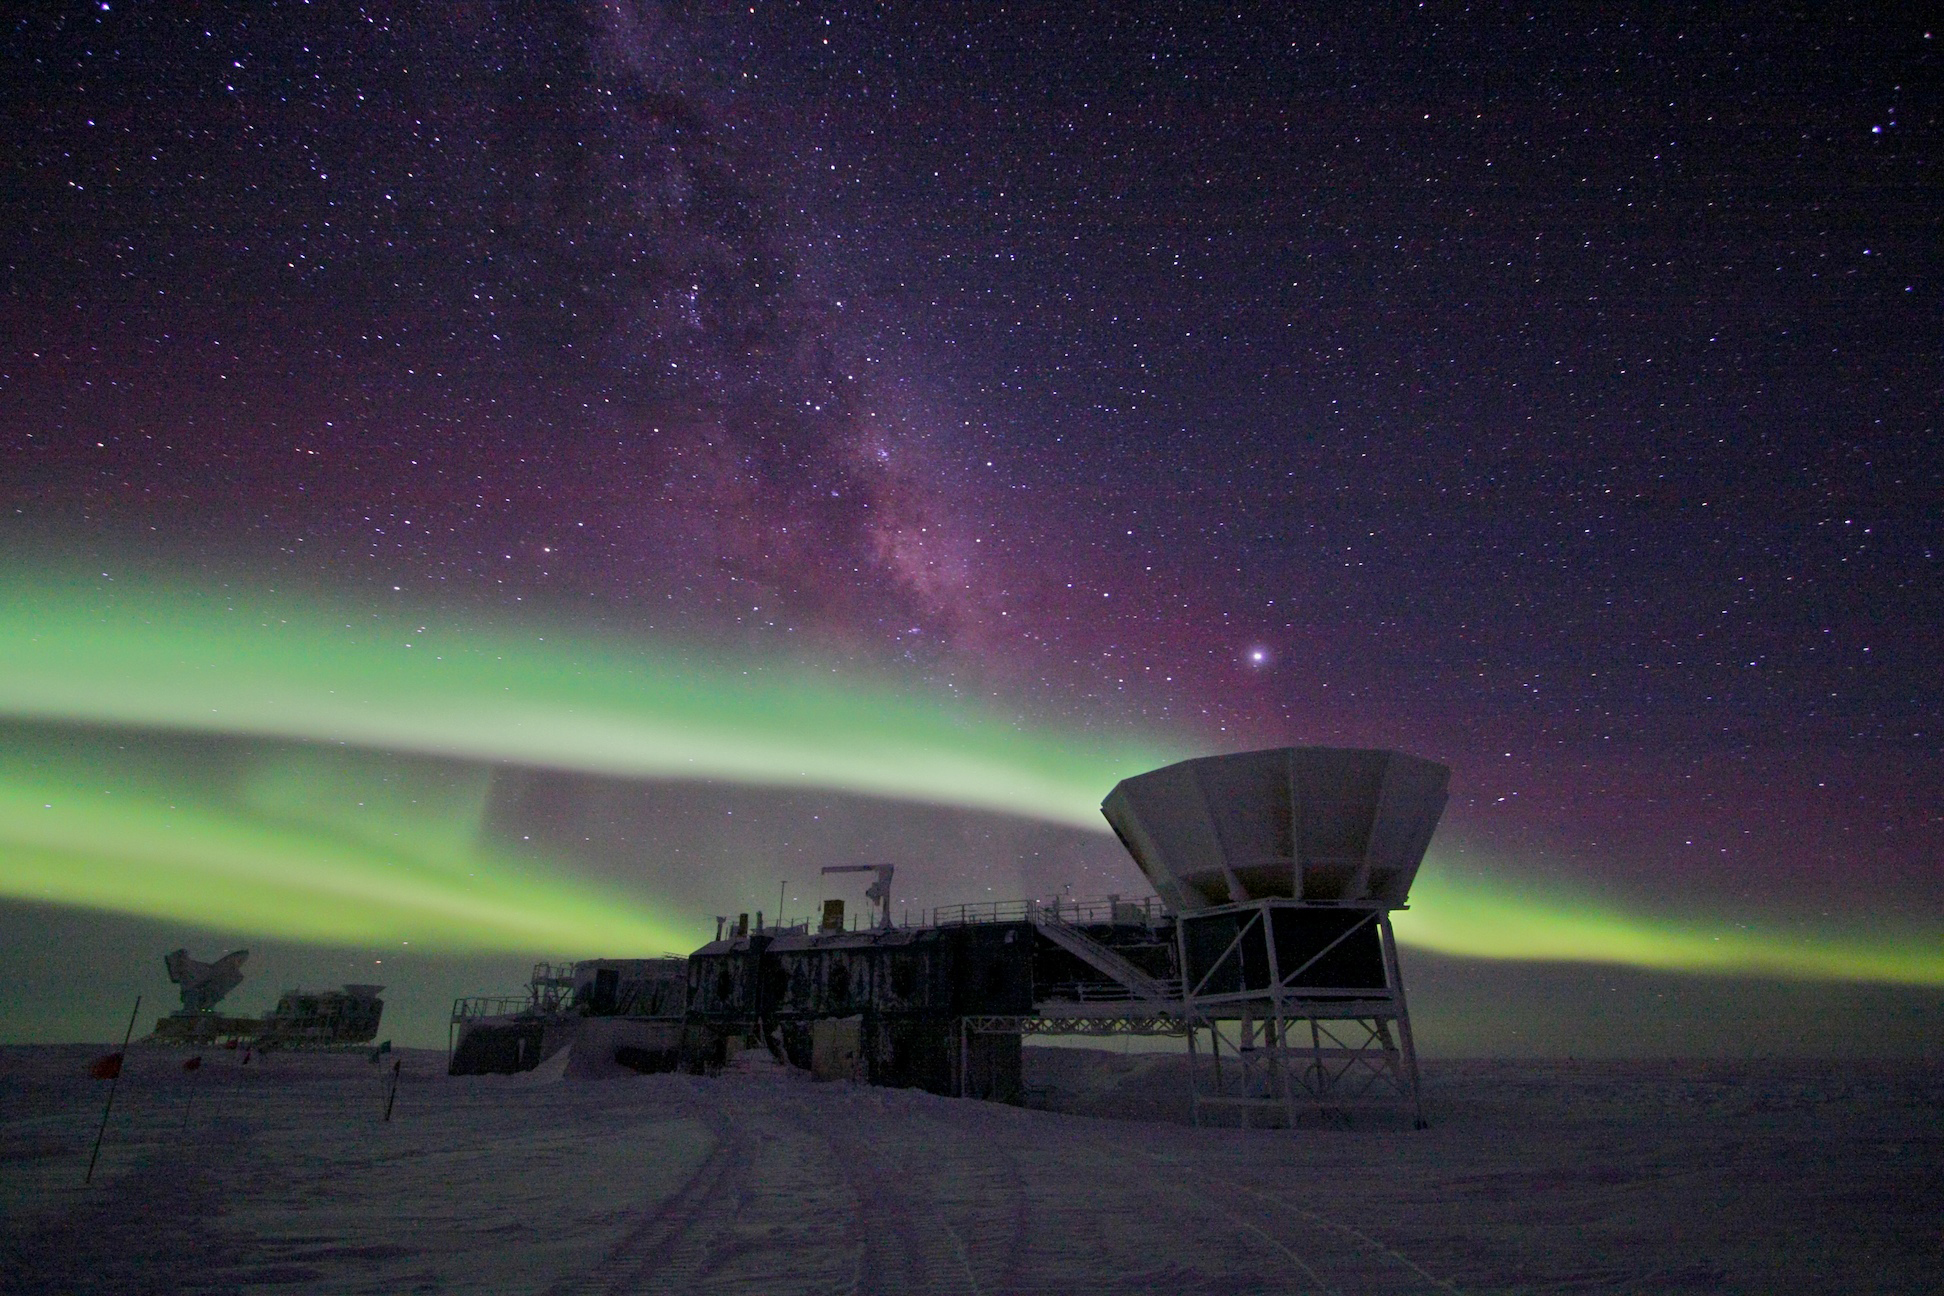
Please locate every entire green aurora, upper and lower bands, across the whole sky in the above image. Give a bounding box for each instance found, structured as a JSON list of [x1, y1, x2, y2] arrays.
[[0, 579, 1944, 985]]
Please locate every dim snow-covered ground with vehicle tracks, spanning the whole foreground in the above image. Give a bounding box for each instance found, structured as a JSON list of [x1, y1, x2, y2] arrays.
[[0, 1047, 1944, 1296]]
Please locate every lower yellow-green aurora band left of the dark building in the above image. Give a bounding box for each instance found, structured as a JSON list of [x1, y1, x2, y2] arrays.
[[0, 744, 694, 952]]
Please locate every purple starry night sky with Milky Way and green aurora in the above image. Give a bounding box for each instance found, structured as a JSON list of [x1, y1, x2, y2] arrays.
[[0, 0, 1944, 1053]]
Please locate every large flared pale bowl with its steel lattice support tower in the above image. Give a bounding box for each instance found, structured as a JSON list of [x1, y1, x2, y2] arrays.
[[1100, 746, 1450, 1127]]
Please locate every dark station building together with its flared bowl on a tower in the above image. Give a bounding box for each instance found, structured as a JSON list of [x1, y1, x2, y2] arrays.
[[453, 748, 1450, 1127]]
